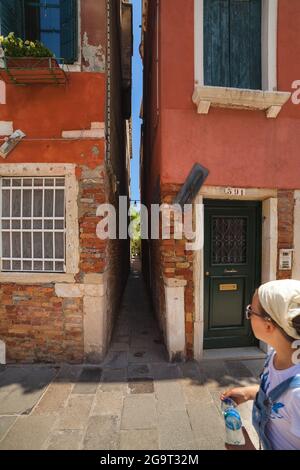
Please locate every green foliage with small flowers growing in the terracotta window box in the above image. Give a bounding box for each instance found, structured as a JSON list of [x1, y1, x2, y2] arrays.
[[0, 33, 53, 57]]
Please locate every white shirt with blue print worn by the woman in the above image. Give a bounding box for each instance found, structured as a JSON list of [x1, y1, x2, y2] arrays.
[[261, 350, 300, 450]]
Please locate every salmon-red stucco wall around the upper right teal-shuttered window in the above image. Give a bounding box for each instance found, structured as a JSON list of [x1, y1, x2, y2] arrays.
[[157, 0, 300, 189]]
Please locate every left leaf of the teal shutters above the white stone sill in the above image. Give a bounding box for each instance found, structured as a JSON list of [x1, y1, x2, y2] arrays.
[[204, 0, 230, 86]]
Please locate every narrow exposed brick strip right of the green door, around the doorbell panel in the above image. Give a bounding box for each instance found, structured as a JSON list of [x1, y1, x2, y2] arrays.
[[277, 190, 295, 279]]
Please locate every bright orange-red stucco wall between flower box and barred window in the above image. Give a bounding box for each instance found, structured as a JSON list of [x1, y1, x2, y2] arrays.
[[0, 72, 106, 166]]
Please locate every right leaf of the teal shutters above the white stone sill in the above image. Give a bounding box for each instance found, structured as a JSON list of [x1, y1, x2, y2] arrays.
[[230, 0, 262, 90]]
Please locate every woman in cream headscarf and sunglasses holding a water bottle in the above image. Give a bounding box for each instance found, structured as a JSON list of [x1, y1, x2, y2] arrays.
[[221, 280, 300, 450]]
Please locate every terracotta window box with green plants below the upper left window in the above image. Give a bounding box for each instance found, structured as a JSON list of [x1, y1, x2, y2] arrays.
[[0, 33, 65, 84]]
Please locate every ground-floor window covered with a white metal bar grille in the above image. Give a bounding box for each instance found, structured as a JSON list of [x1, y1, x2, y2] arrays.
[[0, 177, 66, 273]]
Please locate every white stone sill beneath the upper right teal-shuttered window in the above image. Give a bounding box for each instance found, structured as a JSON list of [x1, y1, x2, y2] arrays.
[[193, 86, 291, 119]]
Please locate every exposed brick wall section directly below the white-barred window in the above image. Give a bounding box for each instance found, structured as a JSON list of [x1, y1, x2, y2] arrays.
[[0, 284, 83, 362]]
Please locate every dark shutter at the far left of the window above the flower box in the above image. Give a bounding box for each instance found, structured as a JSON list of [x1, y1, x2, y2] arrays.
[[0, 0, 23, 36]]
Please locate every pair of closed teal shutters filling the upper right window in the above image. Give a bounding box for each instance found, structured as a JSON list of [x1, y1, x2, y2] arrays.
[[204, 0, 262, 90]]
